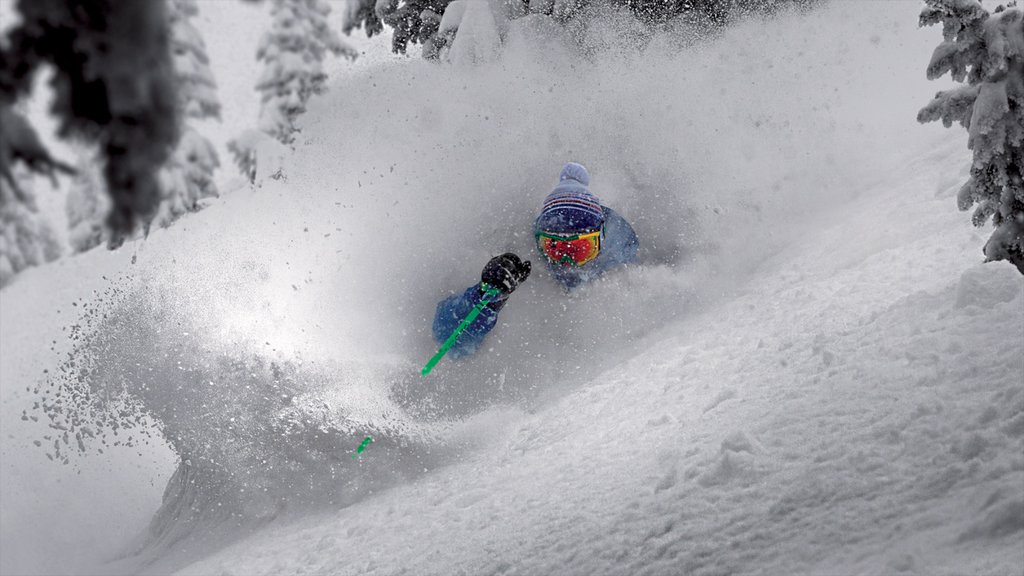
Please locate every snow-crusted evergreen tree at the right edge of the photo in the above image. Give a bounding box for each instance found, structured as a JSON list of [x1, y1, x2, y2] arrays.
[[918, 0, 1024, 274]]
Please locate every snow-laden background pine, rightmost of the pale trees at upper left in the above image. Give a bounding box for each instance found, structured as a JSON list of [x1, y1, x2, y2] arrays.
[[256, 0, 356, 145]]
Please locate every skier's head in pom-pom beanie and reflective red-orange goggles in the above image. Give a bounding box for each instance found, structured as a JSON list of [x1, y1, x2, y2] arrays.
[[534, 162, 604, 265]]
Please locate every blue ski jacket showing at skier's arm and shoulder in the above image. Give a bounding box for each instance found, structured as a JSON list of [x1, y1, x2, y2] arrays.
[[433, 206, 640, 358]]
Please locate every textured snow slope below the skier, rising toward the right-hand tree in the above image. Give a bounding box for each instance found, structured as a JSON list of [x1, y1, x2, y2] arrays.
[[181, 184, 1024, 575]]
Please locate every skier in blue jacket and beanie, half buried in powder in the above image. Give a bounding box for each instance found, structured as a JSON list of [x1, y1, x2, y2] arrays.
[[433, 162, 640, 358]]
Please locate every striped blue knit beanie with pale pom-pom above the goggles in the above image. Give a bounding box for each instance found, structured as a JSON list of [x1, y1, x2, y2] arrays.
[[534, 162, 604, 234]]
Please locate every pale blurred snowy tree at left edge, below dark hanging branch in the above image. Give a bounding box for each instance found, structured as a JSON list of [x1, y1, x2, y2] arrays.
[[0, 164, 60, 286]]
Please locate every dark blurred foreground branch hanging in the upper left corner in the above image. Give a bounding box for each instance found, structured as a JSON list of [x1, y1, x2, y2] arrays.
[[0, 0, 178, 241]]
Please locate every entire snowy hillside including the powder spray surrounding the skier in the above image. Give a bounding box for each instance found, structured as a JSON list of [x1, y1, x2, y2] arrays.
[[0, 2, 1024, 576]]
